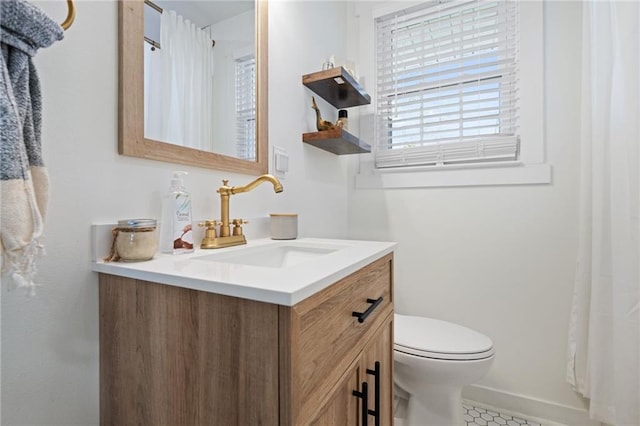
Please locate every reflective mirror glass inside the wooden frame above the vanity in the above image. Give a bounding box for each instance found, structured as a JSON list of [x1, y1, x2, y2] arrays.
[[143, 0, 256, 161]]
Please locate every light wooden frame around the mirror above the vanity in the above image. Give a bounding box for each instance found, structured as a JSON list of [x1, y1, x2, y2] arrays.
[[118, 0, 269, 175]]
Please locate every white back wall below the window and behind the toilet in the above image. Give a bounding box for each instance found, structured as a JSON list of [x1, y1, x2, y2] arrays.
[[349, 1, 584, 422]]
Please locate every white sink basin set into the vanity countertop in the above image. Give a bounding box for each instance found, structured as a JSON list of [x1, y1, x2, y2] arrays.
[[195, 241, 347, 268]]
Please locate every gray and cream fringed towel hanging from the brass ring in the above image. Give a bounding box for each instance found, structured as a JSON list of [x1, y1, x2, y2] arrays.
[[0, 0, 63, 292]]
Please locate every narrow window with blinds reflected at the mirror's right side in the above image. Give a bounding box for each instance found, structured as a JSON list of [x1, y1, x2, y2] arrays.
[[235, 56, 257, 160]]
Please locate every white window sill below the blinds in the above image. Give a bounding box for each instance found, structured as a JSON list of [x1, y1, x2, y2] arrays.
[[356, 163, 551, 189]]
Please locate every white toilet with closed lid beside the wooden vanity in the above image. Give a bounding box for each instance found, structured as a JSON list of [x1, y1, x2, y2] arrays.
[[393, 314, 494, 426]]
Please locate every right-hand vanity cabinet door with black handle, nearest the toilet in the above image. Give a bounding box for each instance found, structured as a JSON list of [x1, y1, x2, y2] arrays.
[[360, 314, 393, 426]]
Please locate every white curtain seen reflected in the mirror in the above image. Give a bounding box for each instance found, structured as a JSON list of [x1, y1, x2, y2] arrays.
[[145, 9, 213, 150]]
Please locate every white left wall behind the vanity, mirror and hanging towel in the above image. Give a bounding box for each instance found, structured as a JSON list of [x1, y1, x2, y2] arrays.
[[0, 0, 348, 426]]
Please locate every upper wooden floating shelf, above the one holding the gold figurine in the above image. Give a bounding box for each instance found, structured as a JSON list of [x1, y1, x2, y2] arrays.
[[302, 67, 371, 108]]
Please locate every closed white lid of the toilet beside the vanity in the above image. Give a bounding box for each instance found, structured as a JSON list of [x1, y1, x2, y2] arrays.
[[394, 314, 494, 360]]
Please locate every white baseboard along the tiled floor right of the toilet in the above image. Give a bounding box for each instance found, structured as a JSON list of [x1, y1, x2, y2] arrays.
[[462, 385, 601, 426]]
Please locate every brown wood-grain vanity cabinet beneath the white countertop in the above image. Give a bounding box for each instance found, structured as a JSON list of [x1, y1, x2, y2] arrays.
[[100, 254, 393, 426]]
